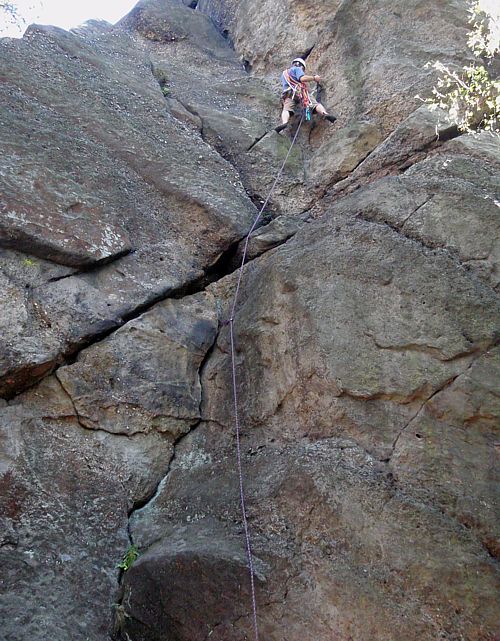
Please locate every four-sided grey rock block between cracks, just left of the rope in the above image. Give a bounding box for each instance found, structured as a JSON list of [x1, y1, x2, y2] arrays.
[[57, 294, 217, 438]]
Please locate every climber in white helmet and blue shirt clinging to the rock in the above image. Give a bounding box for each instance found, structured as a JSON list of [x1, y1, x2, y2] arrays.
[[275, 58, 337, 133]]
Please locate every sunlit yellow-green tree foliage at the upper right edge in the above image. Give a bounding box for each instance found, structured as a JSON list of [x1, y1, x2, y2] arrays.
[[424, 1, 500, 134]]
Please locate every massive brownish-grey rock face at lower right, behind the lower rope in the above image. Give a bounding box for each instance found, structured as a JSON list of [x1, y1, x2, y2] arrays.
[[123, 209, 500, 641]]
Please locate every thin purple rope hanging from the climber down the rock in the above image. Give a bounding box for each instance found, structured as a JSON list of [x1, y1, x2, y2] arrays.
[[228, 113, 304, 641]]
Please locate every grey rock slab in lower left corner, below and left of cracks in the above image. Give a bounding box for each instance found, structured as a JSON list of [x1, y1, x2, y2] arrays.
[[0, 377, 172, 641]]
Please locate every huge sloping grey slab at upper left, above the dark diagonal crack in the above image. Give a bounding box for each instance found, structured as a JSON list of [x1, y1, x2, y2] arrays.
[[0, 17, 255, 397]]
